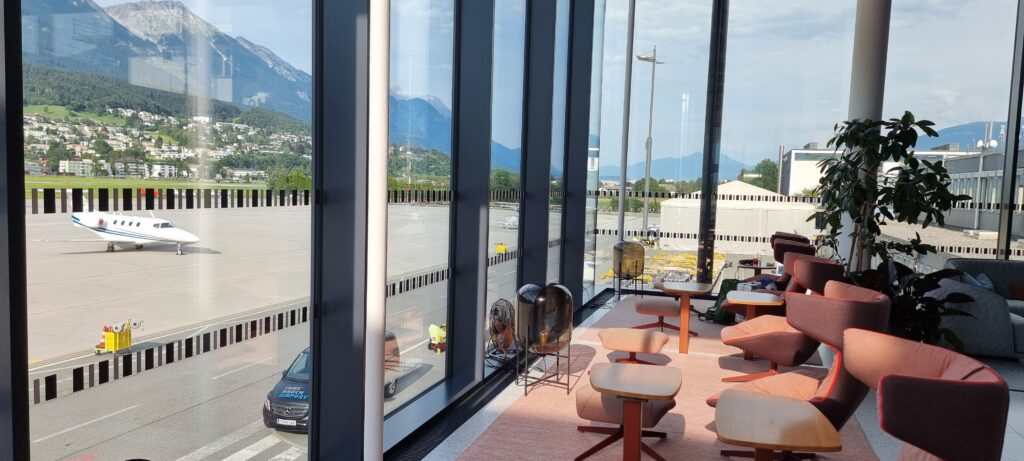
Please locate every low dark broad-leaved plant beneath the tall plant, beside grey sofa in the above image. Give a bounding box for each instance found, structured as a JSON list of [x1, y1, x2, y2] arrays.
[[852, 259, 974, 351]]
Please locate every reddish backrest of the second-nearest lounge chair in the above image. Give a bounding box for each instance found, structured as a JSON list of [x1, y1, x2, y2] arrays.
[[785, 281, 889, 429]]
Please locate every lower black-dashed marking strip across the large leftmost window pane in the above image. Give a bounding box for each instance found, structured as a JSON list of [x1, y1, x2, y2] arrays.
[[29, 306, 309, 405]]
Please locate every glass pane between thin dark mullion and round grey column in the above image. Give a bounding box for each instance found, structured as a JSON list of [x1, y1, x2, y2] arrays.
[[715, 0, 856, 289]]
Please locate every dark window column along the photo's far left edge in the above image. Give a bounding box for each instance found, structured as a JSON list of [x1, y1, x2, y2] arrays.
[[0, 2, 30, 459]]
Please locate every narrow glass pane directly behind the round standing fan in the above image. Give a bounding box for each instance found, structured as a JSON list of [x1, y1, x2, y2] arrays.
[[486, 0, 526, 372]]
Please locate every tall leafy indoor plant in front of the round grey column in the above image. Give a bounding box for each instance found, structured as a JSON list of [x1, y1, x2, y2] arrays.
[[810, 112, 971, 273]]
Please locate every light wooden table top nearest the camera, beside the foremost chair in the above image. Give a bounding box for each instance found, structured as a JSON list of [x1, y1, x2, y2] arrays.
[[715, 389, 843, 452]]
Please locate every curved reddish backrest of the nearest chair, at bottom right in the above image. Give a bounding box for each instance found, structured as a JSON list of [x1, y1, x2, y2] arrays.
[[845, 329, 1010, 461]]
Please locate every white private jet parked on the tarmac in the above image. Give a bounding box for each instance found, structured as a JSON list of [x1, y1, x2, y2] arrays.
[[68, 212, 199, 255]]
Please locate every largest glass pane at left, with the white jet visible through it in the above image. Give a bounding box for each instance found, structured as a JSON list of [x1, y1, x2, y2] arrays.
[[22, 0, 312, 459]]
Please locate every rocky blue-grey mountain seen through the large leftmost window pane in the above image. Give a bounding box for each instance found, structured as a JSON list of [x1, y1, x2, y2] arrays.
[[22, 0, 312, 122]]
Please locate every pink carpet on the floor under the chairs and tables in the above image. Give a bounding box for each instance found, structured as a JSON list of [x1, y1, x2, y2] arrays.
[[459, 301, 878, 461]]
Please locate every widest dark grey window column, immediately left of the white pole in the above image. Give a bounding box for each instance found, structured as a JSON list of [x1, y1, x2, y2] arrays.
[[313, 0, 374, 459]]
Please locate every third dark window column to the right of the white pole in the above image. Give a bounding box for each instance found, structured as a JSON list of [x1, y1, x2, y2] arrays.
[[559, 1, 600, 308]]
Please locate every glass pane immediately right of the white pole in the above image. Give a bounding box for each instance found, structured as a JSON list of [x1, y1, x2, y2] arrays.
[[384, 0, 455, 413]]
